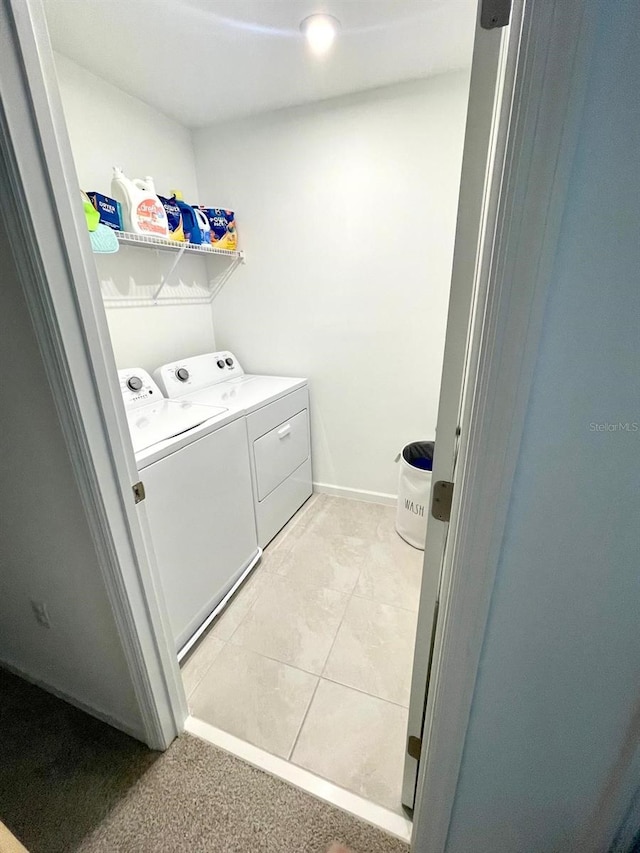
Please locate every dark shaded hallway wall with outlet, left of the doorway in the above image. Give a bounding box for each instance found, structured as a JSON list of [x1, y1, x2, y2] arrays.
[[0, 215, 144, 739]]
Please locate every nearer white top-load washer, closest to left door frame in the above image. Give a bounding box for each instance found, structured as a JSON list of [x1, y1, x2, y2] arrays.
[[118, 368, 262, 659]]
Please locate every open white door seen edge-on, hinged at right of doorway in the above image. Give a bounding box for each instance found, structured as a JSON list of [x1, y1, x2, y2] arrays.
[[402, 0, 520, 809]]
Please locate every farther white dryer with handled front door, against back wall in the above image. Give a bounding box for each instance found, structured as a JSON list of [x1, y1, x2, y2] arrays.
[[153, 350, 312, 548]]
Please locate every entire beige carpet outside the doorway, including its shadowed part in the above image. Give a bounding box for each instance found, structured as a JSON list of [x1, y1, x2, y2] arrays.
[[0, 671, 408, 853]]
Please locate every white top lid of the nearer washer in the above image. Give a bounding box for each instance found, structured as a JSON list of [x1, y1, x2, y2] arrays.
[[127, 400, 227, 453]]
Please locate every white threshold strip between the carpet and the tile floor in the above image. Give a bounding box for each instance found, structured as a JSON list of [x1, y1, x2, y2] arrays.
[[184, 717, 412, 842]]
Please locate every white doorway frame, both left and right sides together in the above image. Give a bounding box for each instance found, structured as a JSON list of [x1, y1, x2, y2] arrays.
[[0, 0, 592, 853]]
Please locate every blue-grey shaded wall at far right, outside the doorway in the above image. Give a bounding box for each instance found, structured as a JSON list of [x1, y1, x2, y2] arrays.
[[438, 0, 640, 853]]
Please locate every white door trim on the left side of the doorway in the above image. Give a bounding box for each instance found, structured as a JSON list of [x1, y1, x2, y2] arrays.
[[0, 0, 188, 749]]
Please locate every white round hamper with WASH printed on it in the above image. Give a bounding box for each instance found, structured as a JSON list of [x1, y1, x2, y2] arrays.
[[396, 441, 434, 551]]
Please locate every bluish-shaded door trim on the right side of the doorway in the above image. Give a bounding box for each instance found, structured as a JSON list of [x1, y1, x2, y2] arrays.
[[412, 0, 594, 853]]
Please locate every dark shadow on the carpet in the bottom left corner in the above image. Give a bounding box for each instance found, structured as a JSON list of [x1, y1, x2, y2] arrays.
[[0, 669, 159, 853]]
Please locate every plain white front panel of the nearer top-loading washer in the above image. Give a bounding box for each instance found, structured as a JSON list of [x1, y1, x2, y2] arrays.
[[141, 419, 258, 651]]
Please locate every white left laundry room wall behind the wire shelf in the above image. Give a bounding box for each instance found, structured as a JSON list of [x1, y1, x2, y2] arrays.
[[55, 54, 214, 370]]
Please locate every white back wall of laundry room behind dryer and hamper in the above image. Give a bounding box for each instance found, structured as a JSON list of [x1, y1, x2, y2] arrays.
[[194, 72, 468, 494]]
